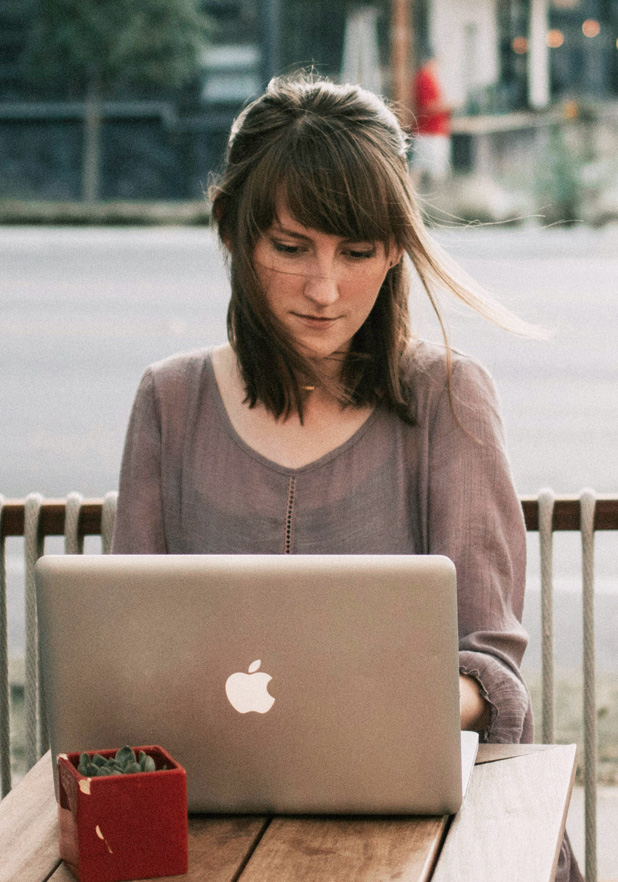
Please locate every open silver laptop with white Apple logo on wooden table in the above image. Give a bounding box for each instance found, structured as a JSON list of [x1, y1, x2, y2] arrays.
[[36, 554, 478, 815]]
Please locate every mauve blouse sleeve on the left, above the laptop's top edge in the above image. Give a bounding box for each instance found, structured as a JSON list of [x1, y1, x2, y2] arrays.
[[112, 368, 167, 554]]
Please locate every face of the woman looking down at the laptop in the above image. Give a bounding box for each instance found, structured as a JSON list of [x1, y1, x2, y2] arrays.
[[253, 206, 401, 358]]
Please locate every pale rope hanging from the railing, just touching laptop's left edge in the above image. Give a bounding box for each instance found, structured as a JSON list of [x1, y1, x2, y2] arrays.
[[24, 493, 43, 769]]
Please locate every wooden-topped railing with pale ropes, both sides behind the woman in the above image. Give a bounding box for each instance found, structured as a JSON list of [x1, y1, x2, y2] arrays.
[[0, 490, 618, 882]]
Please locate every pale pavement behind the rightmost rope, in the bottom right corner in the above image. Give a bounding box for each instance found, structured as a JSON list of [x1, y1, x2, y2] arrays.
[[567, 787, 618, 882]]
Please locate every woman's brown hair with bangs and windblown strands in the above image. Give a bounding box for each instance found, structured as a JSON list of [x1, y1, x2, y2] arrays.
[[210, 74, 526, 423]]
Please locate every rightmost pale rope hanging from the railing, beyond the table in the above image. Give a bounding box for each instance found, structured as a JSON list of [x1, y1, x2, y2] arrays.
[[580, 489, 597, 882]]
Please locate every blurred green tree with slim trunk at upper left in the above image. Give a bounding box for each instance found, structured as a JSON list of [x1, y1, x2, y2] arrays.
[[23, 0, 210, 202]]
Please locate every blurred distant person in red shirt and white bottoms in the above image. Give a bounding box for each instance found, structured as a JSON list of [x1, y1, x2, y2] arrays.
[[410, 53, 452, 188]]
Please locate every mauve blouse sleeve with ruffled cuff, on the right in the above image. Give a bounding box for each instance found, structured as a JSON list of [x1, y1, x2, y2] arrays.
[[428, 358, 532, 743]]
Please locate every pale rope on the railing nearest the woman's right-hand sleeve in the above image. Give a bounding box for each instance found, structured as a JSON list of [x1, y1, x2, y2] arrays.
[[538, 490, 555, 744]]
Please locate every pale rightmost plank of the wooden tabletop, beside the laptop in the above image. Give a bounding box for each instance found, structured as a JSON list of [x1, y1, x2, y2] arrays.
[[431, 744, 576, 882]]
